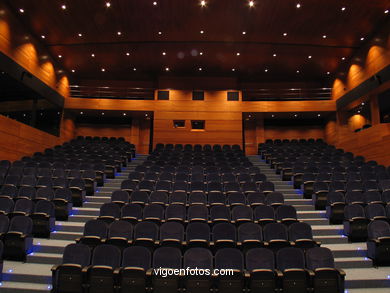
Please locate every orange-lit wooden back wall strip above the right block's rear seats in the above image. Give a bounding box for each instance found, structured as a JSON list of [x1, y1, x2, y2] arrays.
[[264, 126, 325, 139]]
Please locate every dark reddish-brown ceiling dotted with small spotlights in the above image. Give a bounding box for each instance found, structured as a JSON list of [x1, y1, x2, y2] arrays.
[[3, 0, 390, 82]]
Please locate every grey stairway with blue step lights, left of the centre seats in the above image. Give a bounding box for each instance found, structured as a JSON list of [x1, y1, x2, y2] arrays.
[[0, 155, 147, 293]]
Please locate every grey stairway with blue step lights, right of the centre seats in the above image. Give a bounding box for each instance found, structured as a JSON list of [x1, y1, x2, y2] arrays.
[[248, 156, 390, 293]]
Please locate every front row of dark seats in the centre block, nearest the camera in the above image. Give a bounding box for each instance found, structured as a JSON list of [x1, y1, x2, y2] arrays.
[[52, 244, 345, 293]]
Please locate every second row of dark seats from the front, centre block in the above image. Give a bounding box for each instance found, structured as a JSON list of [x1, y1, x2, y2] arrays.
[[76, 219, 321, 251]]
